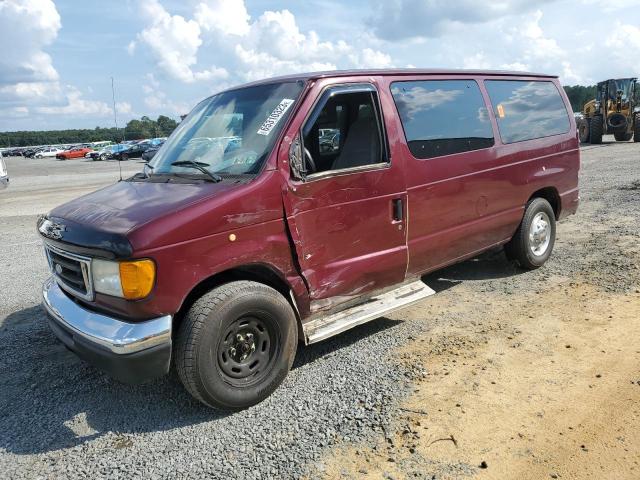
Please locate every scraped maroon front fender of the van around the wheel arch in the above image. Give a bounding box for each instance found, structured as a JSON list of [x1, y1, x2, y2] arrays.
[[87, 171, 308, 319]]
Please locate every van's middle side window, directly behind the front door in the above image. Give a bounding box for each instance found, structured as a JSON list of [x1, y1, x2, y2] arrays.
[[391, 80, 494, 158]]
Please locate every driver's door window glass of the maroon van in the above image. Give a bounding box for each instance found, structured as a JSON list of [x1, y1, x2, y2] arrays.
[[302, 87, 387, 175]]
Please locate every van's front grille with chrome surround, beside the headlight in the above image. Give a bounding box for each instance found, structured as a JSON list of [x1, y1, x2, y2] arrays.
[[45, 244, 93, 300]]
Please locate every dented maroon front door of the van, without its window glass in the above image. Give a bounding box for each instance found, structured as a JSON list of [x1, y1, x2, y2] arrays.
[[279, 77, 407, 311]]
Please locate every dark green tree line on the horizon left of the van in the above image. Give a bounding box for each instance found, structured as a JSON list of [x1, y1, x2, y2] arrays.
[[0, 115, 178, 147]]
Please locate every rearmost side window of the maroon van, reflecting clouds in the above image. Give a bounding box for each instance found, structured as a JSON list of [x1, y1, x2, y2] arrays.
[[485, 80, 570, 143]]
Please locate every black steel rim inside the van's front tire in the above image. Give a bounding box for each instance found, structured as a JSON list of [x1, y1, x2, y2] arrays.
[[216, 315, 280, 386]]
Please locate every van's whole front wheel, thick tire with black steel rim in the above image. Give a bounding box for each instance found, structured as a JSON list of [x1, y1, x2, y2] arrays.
[[175, 281, 298, 410]]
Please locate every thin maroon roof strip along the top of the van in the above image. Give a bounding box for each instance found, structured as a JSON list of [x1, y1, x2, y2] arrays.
[[229, 68, 558, 90]]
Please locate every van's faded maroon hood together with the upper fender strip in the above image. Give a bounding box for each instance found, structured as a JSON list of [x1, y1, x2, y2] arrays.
[[38, 170, 283, 258]]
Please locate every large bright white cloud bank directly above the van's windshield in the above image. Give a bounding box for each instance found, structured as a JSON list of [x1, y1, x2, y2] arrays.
[[137, 0, 392, 86]]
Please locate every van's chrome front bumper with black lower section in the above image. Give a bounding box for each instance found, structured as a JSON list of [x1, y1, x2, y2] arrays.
[[42, 277, 172, 383]]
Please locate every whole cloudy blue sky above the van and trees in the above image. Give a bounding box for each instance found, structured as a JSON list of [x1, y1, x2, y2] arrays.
[[0, 0, 640, 131]]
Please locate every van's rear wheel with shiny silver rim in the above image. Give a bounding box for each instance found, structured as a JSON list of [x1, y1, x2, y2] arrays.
[[505, 198, 556, 270]]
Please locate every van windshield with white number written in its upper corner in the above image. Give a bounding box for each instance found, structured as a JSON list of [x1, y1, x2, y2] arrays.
[[150, 82, 303, 175]]
